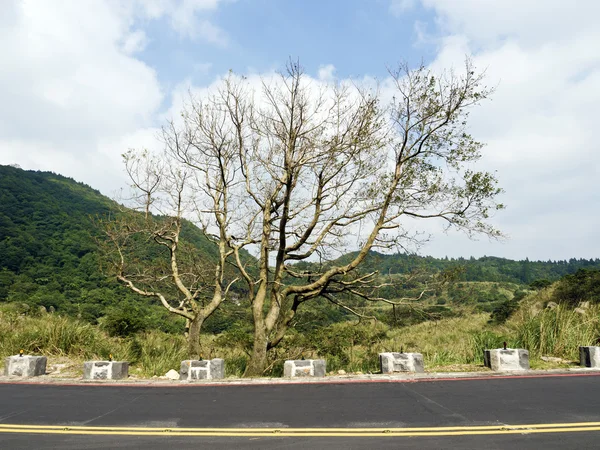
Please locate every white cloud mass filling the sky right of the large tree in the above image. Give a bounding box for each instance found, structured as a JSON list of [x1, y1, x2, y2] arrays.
[[406, 0, 600, 259]]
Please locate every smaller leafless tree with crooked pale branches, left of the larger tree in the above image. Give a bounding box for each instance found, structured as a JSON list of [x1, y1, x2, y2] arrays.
[[103, 148, 236, 358]]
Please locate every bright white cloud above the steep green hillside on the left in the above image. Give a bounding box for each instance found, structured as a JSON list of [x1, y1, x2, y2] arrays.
[[0, 0, 227, 194]]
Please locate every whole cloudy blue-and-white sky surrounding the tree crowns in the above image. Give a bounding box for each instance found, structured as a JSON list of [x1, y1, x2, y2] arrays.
[[0, 0, 600, 260]]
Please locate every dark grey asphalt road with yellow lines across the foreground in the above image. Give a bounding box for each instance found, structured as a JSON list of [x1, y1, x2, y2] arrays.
[[0, 375, 600, 449]]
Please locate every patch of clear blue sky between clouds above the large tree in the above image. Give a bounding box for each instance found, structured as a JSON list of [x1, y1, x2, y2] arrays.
[[139, 0, 435, 83]]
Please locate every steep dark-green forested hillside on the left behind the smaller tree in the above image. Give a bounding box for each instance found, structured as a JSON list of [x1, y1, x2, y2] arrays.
[[0, 166, 214, 332]]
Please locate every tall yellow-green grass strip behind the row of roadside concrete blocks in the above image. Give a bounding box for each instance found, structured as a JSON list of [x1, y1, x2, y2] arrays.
[[0, 290, 600, 377]]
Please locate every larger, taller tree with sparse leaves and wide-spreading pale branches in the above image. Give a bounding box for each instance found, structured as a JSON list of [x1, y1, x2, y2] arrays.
[[102, 62, 502, 375]]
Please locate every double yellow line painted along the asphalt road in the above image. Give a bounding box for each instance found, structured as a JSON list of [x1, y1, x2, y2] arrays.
[[0, 422, 600, 437]]
